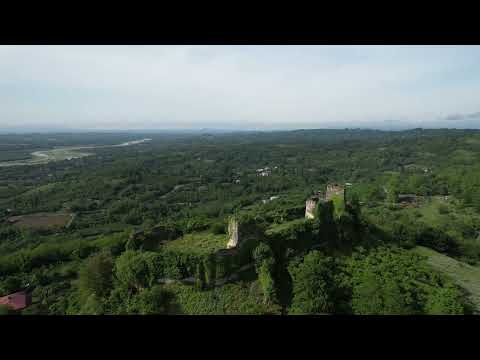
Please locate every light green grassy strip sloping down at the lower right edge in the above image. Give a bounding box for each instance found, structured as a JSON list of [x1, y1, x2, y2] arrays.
[[413, 246, 480, 314]]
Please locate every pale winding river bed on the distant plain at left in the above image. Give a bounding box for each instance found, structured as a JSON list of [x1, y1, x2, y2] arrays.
[[0, 139, 151, 167]]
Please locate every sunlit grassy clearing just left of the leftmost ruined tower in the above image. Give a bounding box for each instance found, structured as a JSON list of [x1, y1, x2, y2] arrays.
[[163, 232, 228, 255]]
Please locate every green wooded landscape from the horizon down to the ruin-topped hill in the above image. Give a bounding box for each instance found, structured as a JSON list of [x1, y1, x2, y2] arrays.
[[0, 129, 480, 315]]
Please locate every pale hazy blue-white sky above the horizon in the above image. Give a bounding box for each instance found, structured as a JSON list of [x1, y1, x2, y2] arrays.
[[0, 45, 480, 130]]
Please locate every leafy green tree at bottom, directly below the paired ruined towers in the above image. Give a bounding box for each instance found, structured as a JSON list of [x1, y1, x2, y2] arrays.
[[289, 251, 336, 314]]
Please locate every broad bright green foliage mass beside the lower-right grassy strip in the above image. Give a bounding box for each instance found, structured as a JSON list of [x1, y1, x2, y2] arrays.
[[350, 247, 463, 315]]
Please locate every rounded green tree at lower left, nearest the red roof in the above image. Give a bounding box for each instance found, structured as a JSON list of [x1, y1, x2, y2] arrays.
[[79, 252, 113, 297]]
